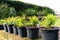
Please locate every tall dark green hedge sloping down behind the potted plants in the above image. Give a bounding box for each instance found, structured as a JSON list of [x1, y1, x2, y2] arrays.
[[0, 1, 55, 19]]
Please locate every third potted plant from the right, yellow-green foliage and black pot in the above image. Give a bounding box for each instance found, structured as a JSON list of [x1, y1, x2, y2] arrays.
[[16, 16, 27, 37]]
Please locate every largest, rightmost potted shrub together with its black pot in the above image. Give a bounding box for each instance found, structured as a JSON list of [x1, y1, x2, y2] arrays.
[[40, 15, 59, 40]]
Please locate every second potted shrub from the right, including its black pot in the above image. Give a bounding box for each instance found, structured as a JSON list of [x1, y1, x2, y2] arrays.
[[26, 16, 39, 39]]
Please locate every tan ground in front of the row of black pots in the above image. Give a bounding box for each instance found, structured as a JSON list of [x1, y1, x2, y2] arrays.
[[0, 30, 41, 40]]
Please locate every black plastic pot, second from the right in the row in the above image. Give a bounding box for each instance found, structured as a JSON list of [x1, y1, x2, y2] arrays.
[[27, 27, 39, 39]]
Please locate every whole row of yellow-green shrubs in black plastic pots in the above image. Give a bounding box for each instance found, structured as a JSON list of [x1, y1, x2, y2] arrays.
[[0, 15, 59, 40]]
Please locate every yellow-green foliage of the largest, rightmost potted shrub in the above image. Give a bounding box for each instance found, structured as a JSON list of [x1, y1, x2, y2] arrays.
[[40, 15, 56, 29]]
